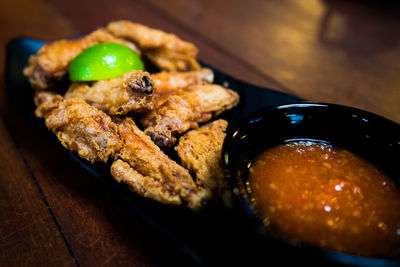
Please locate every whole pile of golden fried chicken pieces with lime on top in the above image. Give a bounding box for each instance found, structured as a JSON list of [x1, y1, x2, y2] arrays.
[[24, 21, 239, 210]]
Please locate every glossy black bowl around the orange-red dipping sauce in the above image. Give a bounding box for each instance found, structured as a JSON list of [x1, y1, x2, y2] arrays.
[[222, 102, 400, 266]]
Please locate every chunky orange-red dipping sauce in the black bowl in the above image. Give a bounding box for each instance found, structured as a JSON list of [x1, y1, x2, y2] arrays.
[[249, 141, 400, 257]]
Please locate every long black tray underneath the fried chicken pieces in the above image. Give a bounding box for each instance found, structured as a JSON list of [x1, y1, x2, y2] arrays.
[[5, 37, 306, 265]]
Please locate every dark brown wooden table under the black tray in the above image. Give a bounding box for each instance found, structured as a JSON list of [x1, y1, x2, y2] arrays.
[[0, 0, 400, 266]]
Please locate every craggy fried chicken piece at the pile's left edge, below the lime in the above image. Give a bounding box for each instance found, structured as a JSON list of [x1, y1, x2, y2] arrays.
[[36, 94, 122, 163]]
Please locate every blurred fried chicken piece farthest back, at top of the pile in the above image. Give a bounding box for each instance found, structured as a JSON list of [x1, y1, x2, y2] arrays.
[[107, 21, 200, 71]]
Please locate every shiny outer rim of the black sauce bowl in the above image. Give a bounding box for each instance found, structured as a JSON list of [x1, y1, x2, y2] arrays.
[[222, 101, 400, 266]]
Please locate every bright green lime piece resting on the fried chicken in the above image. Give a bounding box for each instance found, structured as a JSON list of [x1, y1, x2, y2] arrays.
[[69, 43, 144, 82]]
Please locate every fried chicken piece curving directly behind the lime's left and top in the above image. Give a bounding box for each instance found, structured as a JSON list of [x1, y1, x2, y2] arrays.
[[24, 29, 138, 90]]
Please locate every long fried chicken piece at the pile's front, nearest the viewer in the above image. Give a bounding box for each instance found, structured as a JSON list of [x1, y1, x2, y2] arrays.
[[111, 118, 205, 209]]
